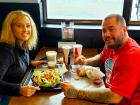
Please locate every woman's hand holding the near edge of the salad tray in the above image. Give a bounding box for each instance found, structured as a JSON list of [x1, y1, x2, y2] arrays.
[[20, 86, 40, 96]]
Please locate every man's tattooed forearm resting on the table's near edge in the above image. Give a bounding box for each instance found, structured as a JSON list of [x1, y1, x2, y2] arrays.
[[77, 88, 122, 103]]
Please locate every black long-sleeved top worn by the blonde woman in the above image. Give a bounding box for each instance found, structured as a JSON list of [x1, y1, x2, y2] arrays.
[[0, 43, 30, 96]]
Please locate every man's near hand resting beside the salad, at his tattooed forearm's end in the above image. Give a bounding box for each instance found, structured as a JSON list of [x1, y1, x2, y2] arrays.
[[61, 82, 78, 98]]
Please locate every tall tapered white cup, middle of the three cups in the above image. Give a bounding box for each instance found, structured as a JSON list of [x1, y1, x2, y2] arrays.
[[62, 46, 72, 65]]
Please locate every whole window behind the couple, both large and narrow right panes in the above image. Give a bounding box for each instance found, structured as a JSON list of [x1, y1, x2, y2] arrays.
[[42, 0, 140, 25]]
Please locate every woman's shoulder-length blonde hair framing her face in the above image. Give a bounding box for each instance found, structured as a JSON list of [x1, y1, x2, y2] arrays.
[[0, 10, 38, 50]]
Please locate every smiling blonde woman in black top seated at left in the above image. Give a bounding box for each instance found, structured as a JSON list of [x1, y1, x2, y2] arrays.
[[0, 10, 45, 99]]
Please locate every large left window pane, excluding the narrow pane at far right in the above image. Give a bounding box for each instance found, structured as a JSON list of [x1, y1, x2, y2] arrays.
[[43, 0, 124, 24]]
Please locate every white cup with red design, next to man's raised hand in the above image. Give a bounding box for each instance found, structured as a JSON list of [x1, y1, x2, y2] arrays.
[[73, 44, 83, 60]]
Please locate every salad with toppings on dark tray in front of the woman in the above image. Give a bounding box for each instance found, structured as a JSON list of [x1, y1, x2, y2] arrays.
[[21, 65, 63, 91]]
